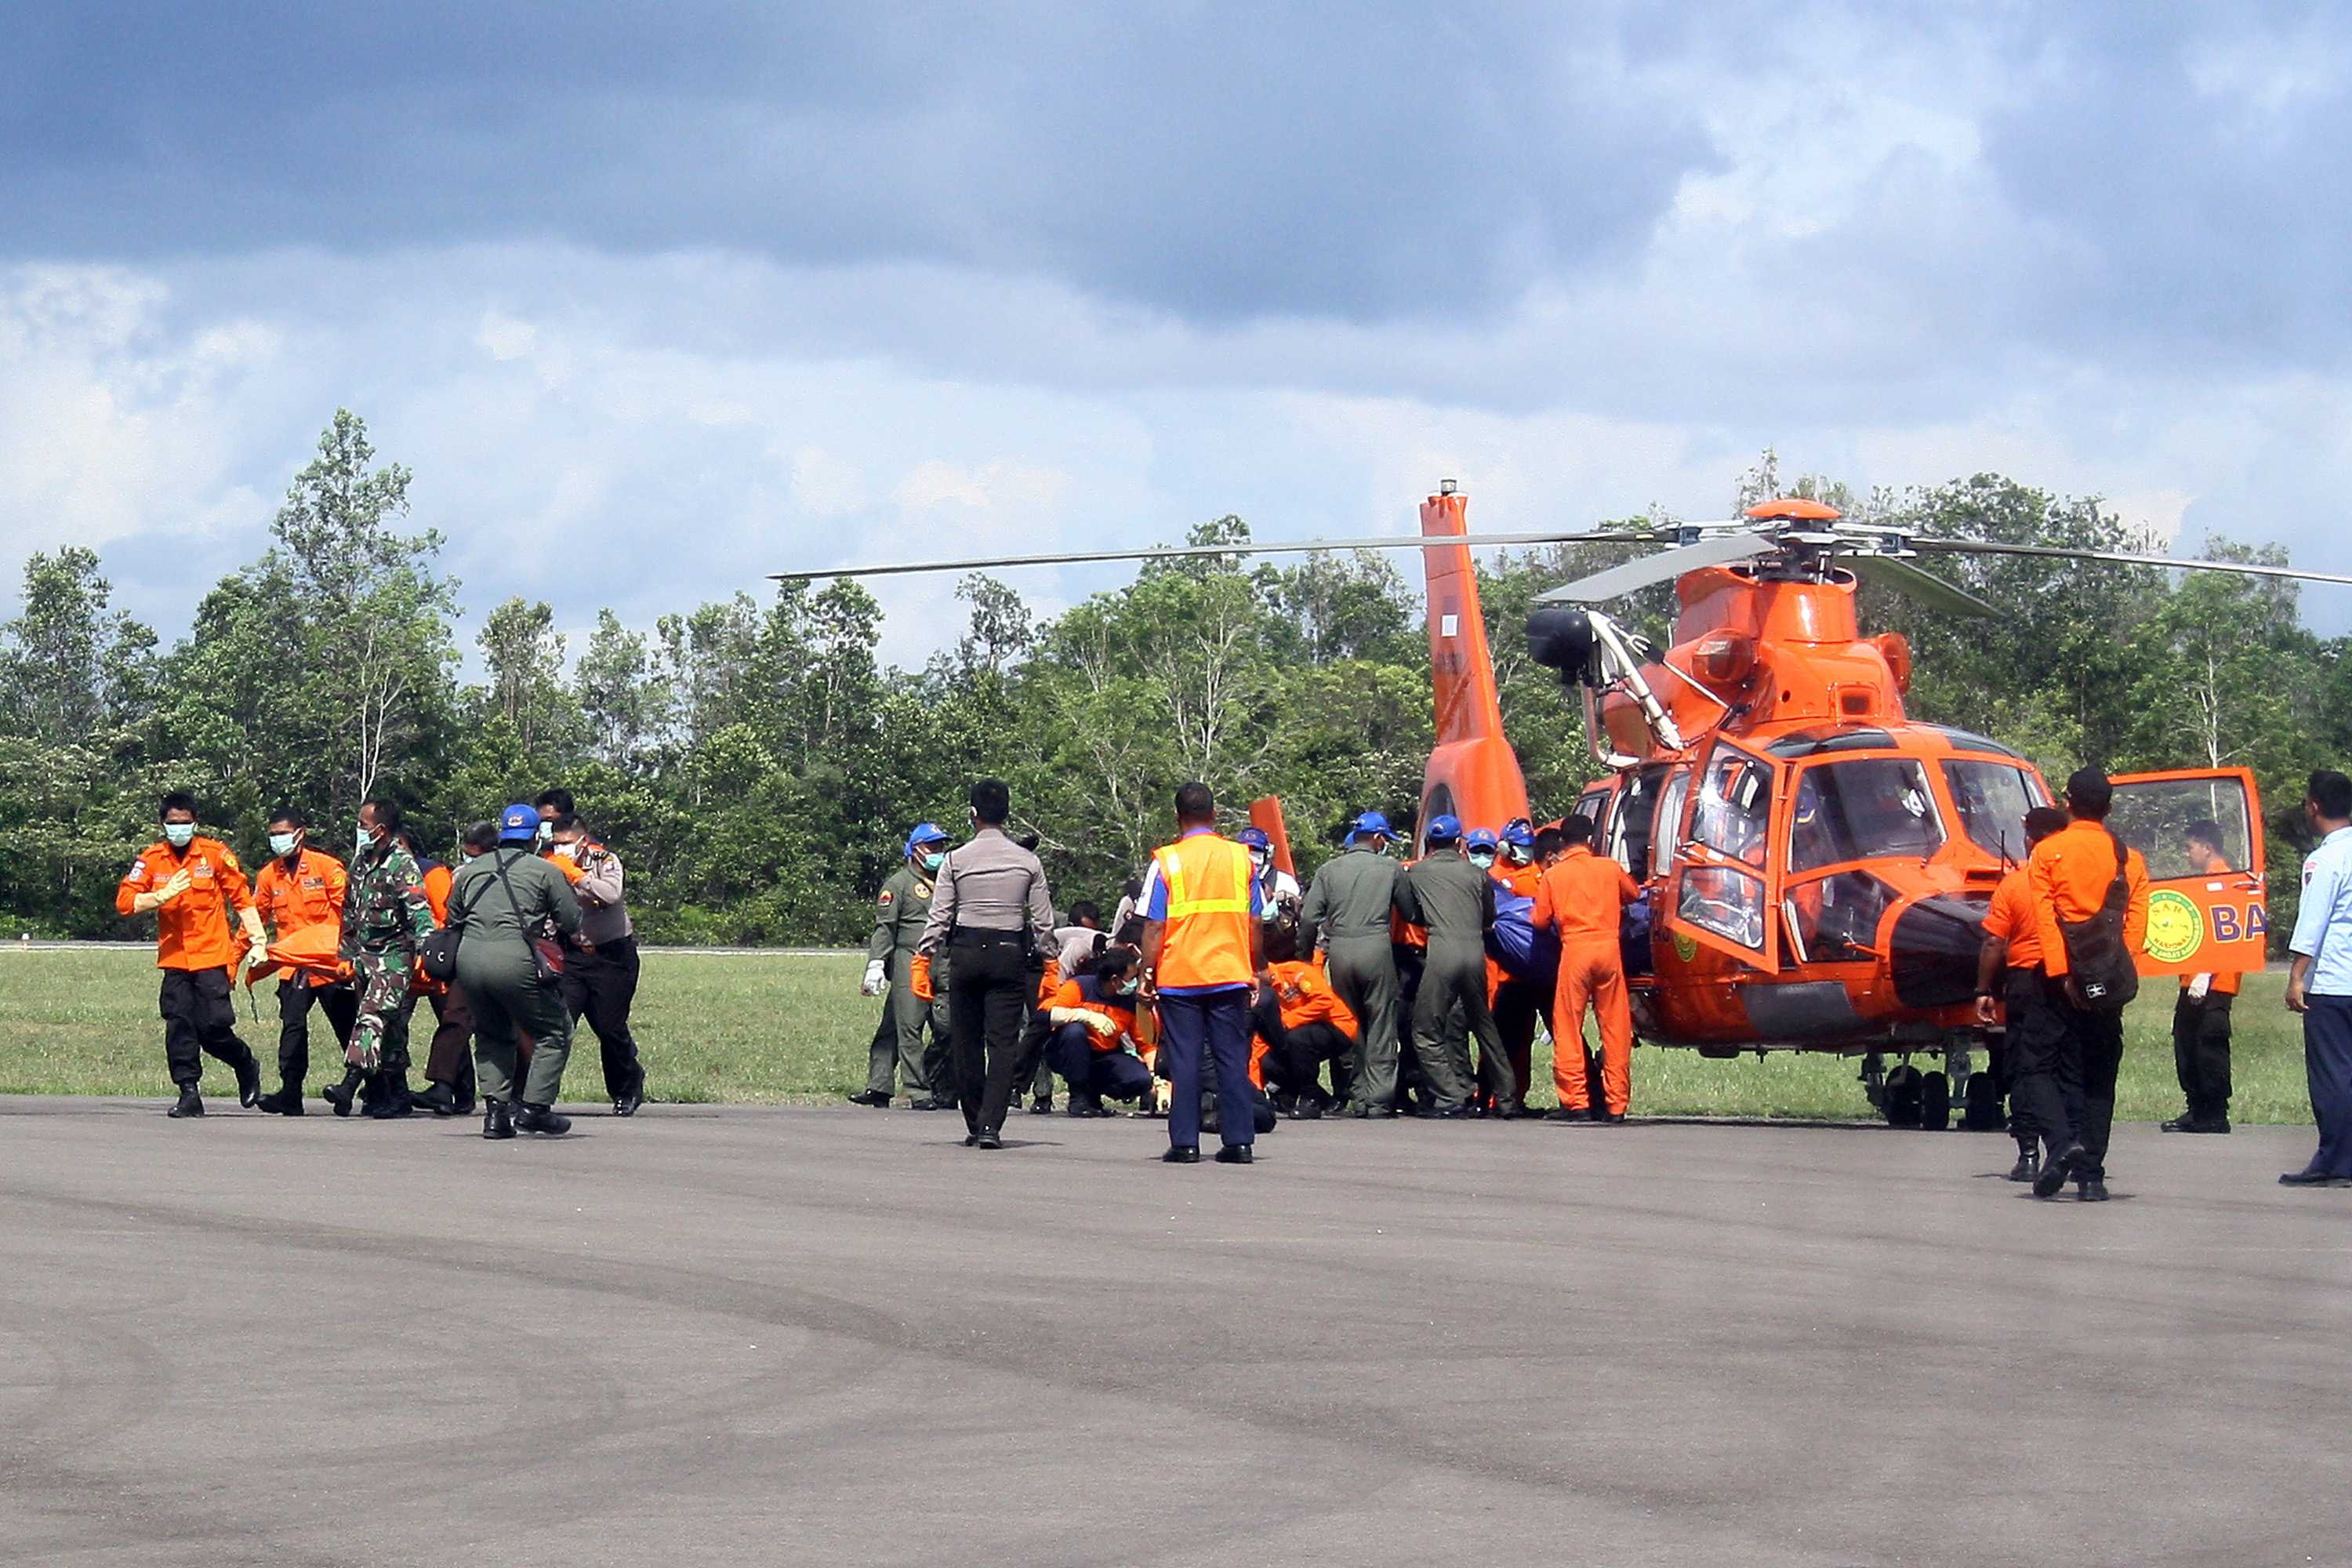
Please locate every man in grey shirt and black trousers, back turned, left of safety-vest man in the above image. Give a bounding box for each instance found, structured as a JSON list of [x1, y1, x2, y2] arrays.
[[917, 779, 1054, 1149]]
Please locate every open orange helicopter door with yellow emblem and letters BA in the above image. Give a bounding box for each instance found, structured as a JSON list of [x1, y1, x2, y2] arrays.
[[2107, 769, 2270, 975]]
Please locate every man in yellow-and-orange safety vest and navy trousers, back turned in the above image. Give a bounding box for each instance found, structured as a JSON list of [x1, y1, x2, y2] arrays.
[[1143, 783, 1265, 1166]]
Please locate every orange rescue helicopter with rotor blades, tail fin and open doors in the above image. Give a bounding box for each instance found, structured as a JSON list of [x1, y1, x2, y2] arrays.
[[776, 480, 2352, 1128]]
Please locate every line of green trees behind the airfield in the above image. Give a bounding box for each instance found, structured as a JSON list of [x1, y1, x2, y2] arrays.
[[0, 412, 2352, 945]]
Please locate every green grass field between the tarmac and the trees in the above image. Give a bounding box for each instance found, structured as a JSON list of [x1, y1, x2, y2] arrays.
[[0, 947, 2310, 1121]]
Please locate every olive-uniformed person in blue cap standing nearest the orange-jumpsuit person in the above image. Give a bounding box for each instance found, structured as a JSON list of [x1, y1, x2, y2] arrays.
[[1397, 815, 1512, 1116]]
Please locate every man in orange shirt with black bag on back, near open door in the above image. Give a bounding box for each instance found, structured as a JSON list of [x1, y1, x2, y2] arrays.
[[2018, 769, 2147, 1203]]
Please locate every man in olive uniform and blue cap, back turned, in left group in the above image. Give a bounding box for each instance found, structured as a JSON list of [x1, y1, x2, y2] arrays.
[[449, 806, 581, 1138]]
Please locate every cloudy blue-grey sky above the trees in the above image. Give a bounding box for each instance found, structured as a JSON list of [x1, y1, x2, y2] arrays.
[[0, 0, 2352, 659]]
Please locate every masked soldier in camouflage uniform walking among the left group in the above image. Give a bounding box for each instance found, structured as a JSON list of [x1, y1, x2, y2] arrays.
[[325, 799, 433, 1119]]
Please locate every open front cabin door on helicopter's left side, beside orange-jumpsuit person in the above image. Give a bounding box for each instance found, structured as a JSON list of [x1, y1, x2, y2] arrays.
[[1661, 741, 1788, 973]]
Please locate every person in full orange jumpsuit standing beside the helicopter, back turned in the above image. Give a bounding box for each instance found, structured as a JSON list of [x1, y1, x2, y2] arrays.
[[1534, 815, 1642, 1123]]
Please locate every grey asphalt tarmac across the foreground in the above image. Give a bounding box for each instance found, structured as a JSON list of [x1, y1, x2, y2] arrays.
[[0, 1100, 2352, 1568]]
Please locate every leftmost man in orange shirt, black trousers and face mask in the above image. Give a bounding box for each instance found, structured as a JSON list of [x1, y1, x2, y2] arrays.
[[115, 789, 268, 1119]]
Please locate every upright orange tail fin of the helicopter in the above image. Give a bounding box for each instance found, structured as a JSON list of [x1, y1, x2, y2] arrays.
[[1416, 494, 1526, 837]]
